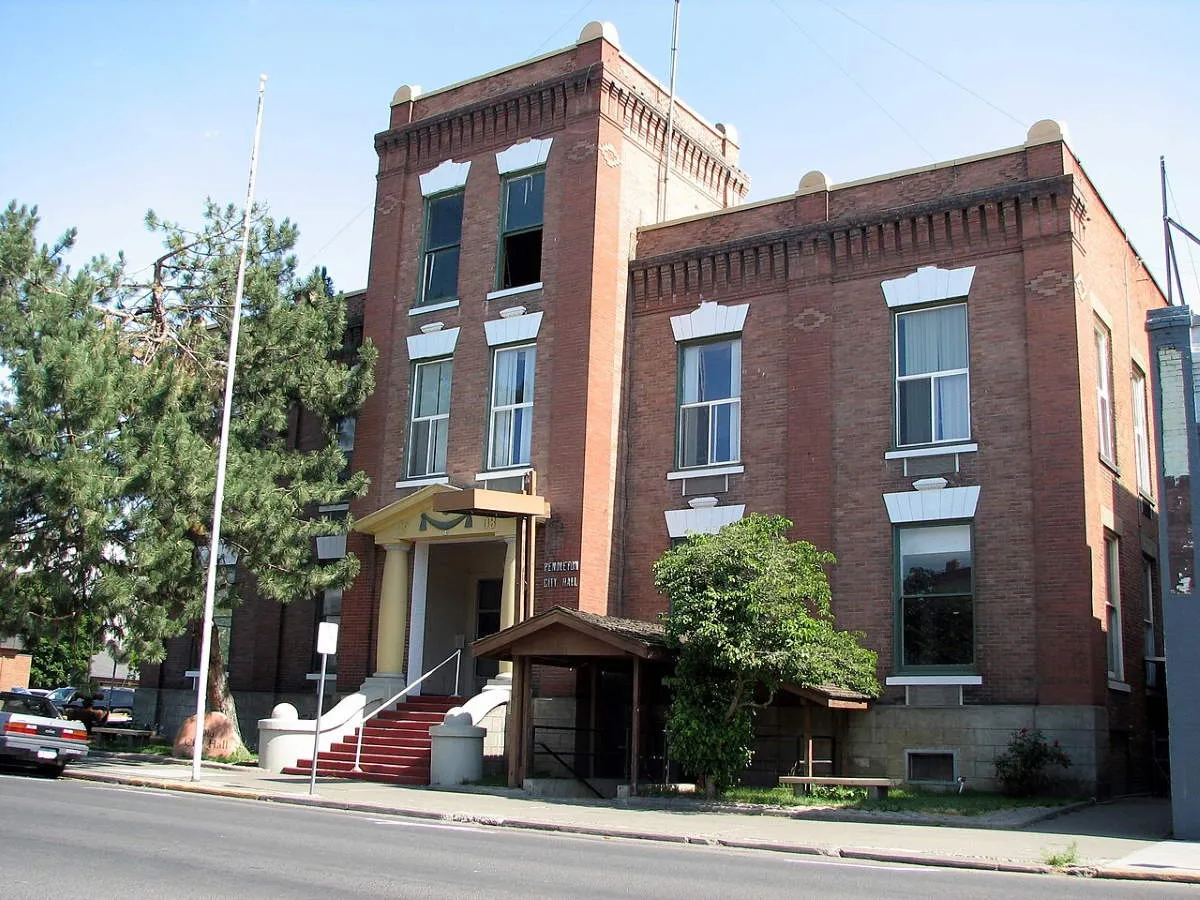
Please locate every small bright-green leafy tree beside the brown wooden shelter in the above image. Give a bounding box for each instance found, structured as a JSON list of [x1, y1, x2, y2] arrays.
[[654, 515, 880, 797]]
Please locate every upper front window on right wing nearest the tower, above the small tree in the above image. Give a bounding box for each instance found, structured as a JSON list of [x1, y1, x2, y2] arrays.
[[679, 338, 742, 468]]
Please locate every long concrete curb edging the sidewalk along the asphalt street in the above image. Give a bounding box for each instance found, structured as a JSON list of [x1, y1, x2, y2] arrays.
[[64, 772, 1200, 884]]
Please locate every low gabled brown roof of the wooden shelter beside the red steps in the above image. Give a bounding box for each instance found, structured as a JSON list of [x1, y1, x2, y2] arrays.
[[472, 606, 668, 667]]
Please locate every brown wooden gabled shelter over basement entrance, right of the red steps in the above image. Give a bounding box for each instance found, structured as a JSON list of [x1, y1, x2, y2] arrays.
[[472, 606, 671, 790]]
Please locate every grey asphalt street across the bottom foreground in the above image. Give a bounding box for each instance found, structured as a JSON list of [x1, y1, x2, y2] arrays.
[[0, 774, 1195, 900]]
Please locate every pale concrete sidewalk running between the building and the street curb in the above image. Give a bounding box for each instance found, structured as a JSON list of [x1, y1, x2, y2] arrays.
[[66, 754, 1200, 884]]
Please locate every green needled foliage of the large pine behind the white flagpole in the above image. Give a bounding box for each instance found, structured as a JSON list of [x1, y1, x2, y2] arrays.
[[0, 203, 374, 662]]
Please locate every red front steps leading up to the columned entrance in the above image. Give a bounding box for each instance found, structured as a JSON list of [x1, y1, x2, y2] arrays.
[[283, 696, 463, 785]]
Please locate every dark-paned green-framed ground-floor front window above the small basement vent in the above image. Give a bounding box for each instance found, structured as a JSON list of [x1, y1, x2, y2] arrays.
[[896, 523, 974, 670]]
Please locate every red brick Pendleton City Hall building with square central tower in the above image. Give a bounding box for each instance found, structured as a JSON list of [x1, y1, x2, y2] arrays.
[[138, 23, 1164, 792]]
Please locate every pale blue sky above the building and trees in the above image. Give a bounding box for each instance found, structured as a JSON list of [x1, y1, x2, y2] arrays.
[[0, 0, 1200, 306]]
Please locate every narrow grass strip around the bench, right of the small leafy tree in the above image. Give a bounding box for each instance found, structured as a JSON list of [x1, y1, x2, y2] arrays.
[[721, 785, 1072, 816]]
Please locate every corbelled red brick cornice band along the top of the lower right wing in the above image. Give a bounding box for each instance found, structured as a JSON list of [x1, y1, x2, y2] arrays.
[[629, 175, 1087, 312]]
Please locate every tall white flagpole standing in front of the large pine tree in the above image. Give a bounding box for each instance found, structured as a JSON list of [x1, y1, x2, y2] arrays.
[[192, 76, 270, 781]]
